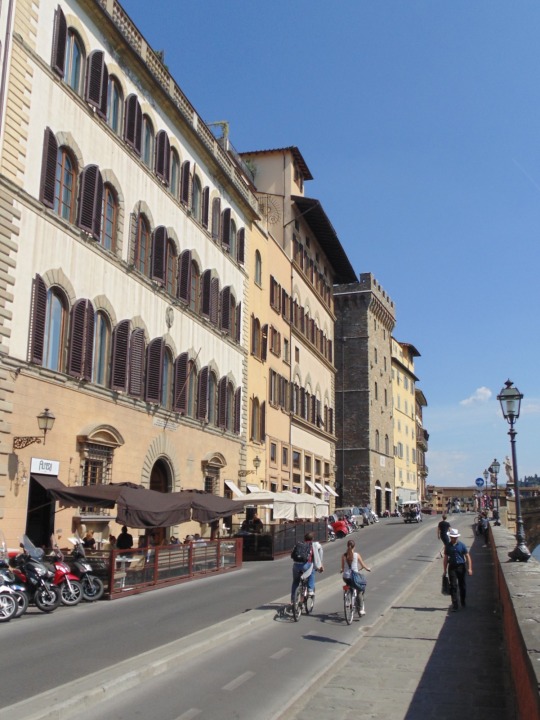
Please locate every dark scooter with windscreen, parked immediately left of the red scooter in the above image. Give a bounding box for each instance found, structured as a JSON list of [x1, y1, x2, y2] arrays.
[[9, 535, 62, 612]]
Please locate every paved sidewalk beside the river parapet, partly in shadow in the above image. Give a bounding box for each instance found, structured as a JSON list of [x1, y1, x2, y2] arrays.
[[281, 516, 516, 720]]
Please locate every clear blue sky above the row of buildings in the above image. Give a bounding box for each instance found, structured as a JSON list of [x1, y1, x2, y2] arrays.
[[124, 0, 540, 485]]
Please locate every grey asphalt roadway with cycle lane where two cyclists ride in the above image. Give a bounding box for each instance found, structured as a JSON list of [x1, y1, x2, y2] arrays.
[[0, 518, 438, 720]]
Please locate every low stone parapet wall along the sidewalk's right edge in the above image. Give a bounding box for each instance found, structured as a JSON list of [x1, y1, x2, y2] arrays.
[[491, 525, 540, 720]]
